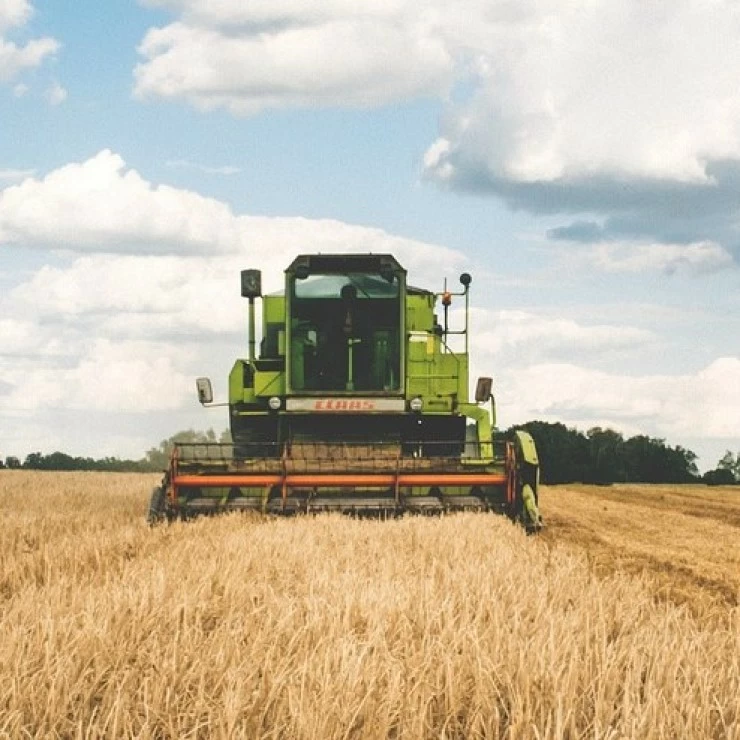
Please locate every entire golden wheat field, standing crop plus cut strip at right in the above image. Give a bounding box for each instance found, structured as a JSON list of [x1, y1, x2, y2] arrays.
[[0, 471, 740, 740]]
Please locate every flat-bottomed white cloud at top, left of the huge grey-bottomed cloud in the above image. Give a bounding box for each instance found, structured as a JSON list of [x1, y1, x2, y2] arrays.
[[135, 5, 454, 115]]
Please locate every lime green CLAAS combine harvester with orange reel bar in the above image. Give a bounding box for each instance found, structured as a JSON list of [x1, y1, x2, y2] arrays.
[[149, 254, 541, 531]]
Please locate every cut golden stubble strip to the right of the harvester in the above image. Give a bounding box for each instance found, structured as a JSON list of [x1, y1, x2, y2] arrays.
[[542, 485, 740, 621]]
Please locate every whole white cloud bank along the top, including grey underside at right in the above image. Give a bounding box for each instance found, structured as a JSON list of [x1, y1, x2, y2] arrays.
[[135, 0, 740, 264]]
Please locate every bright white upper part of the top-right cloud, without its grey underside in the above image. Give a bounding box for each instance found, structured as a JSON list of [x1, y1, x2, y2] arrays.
[[427, 0, 740, 183]]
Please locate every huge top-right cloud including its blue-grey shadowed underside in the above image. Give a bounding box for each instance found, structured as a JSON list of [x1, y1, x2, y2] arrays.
[[416, 0, 740, 259]]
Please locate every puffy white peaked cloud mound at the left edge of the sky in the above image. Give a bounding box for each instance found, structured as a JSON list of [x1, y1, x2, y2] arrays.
[[0, 150, 242, 254]]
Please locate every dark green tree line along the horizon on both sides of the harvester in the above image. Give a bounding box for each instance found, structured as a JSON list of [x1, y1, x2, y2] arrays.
[[0, 421, 740, 485]]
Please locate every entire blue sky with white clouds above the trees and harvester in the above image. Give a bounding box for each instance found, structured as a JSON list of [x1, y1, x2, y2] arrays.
[[0, 0, 740, 468]]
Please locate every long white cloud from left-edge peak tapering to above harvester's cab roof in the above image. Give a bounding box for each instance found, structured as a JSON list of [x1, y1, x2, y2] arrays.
[[0, 150, 463, 274]]
